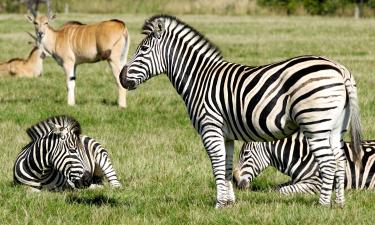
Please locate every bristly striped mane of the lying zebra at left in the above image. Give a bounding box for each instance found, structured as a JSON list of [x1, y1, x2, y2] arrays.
[[26, 115, 82, 141]]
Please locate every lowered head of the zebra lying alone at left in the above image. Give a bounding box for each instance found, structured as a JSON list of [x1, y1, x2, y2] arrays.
[[48, 120, 92, 188]]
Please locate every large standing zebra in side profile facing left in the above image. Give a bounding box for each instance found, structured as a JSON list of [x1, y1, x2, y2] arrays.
[[120, 15, 360, 208]]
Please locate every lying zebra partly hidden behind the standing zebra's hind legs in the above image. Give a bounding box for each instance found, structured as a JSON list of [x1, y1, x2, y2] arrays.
[[234, 133, 375, 194]]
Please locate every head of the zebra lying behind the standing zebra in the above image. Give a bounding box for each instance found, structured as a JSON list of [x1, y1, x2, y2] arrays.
[[233, 142, 269, 189]]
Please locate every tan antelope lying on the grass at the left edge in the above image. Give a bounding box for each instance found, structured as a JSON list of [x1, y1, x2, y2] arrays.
[[0, 47, 45, 77]]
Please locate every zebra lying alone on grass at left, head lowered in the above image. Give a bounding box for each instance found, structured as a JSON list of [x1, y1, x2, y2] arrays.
[[13, 116, 121, 191]]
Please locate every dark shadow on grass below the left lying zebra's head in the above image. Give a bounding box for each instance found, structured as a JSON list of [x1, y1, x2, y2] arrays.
[[66, 194, 130, 207]]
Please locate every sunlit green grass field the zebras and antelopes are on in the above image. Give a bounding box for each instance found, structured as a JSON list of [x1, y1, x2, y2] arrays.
[[0, 14, 375, 224]]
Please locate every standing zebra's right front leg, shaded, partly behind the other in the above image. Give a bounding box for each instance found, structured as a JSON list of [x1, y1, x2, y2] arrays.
[[225, 140, 236, 205]]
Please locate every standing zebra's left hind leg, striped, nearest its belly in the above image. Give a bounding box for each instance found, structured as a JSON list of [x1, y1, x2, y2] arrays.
[[305, 133, 336, 205]]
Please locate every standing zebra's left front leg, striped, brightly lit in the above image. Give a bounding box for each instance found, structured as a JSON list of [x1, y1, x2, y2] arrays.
[[201, 126, 228, 208]]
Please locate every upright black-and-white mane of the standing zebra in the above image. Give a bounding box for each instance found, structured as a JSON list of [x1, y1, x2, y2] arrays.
[[142, 14, 222, 58]]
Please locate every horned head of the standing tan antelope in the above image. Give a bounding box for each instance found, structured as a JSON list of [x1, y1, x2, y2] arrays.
[[26, 0, 56, 43]]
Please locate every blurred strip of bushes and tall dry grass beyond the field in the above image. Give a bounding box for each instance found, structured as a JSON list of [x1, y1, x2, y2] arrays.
[[0, 0, 375, 16]]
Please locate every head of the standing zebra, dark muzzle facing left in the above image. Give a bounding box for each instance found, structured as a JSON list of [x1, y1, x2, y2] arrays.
[[120, 18, 166, 90]]
